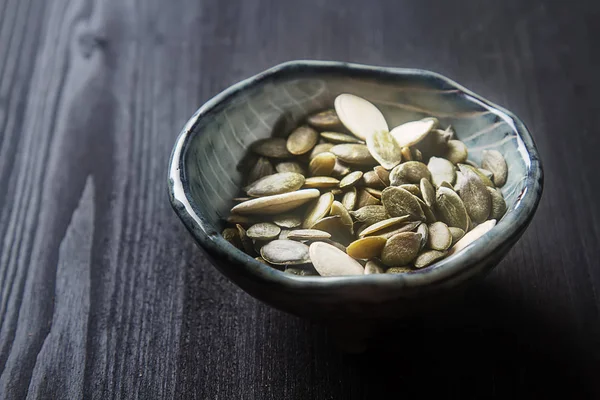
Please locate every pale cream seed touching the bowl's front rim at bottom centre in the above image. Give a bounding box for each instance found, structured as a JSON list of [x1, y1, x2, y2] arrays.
[[309, 242, 364, 276]]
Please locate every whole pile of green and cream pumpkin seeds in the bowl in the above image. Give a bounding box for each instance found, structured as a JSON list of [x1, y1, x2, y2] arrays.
[[223, 94, 508, 276]]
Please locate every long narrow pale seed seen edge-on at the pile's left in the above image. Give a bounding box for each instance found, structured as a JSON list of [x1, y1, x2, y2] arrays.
[[231, 189, 324, 214]]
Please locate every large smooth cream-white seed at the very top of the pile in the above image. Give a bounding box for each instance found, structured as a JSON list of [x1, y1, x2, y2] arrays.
[[334, 93, 389, 140]]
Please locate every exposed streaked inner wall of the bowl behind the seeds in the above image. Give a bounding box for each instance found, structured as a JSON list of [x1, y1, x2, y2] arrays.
[[183, 68, 530, 232]]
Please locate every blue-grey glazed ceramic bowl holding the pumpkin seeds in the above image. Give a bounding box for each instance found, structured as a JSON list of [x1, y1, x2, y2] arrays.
[[168, 61, 543, 320]]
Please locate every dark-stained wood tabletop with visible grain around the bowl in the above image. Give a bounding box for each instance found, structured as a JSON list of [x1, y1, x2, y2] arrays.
[[0, 0, 600, 399]]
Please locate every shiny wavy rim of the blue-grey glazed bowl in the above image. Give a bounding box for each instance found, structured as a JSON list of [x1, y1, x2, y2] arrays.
[[168, 60, 544, 292]]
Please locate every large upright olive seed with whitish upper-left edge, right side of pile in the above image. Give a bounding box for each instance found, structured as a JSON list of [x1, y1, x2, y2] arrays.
[[455, 168, 492, 224]]
